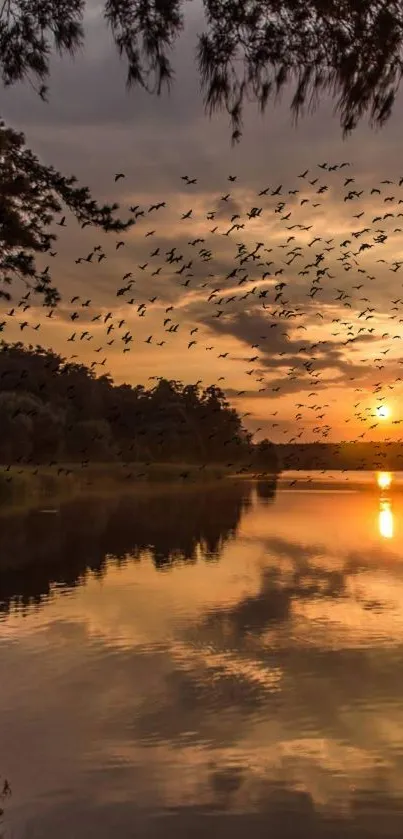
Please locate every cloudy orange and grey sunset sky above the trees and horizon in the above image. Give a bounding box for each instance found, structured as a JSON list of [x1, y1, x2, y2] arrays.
[[2, 3, 403, 442]]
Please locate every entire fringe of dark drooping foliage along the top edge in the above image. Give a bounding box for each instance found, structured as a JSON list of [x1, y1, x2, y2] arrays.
[[0, 0, 403, 140]]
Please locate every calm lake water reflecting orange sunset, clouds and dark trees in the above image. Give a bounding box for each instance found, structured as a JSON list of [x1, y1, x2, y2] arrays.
[[0, 475, 403, 839]]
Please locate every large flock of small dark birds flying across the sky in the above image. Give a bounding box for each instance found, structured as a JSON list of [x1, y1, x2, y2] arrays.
[[0, 162, 403, 452]]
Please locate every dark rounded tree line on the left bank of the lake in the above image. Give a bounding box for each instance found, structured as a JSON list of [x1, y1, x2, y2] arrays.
[[0, 341, 278, 472]]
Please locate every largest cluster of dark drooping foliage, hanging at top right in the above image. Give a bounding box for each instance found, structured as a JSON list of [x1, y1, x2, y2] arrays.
[[198, 0, 403, 139]]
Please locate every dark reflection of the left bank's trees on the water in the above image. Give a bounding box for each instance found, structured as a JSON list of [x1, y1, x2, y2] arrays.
[[0, 481, 266, 612]]
